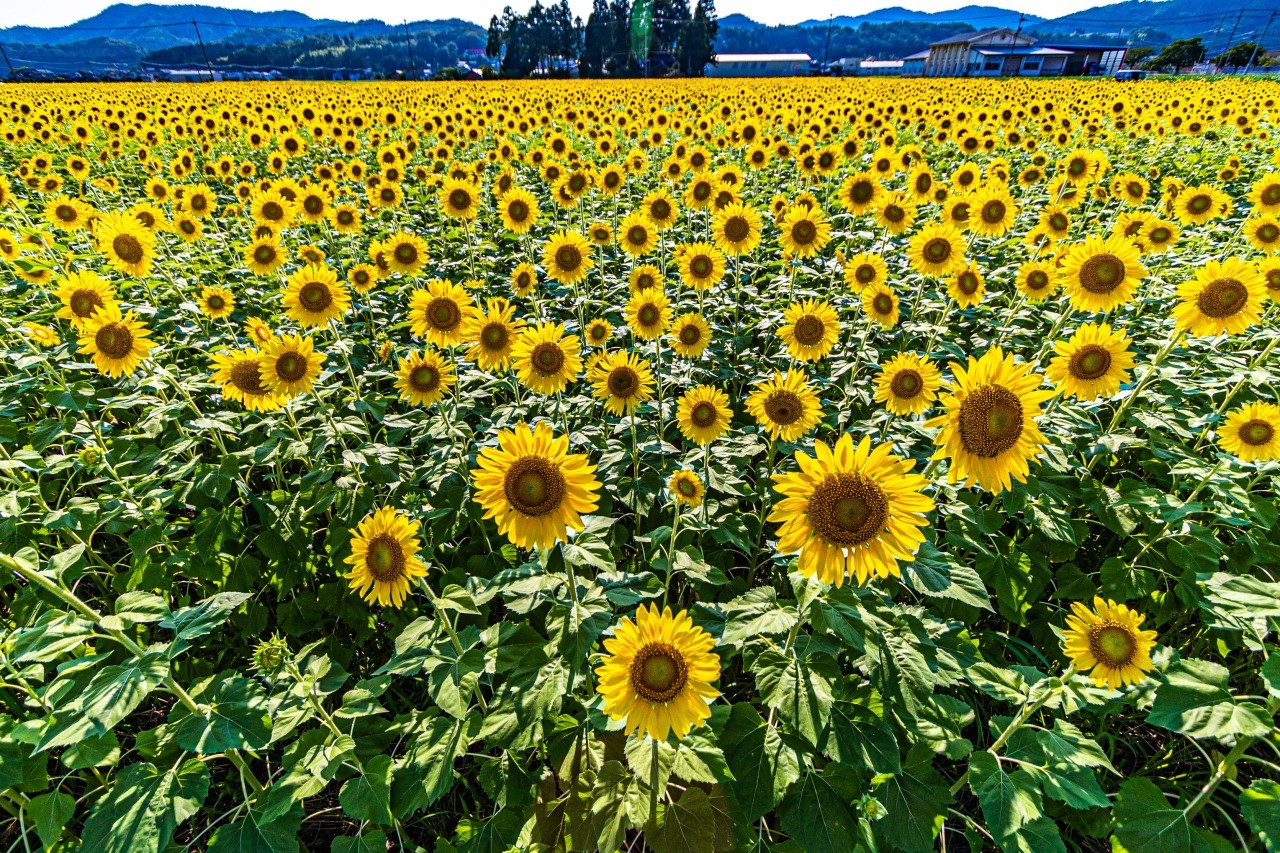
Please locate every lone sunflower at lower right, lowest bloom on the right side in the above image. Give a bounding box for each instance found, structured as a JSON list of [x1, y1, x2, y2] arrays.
[[1064, 598, 1156, 690]]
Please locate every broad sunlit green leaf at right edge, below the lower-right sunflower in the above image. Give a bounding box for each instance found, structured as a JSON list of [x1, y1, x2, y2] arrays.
[[1147, 657, 1271, 738]]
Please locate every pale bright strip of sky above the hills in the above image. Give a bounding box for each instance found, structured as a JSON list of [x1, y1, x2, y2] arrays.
[[0, 0, 1106, 27]]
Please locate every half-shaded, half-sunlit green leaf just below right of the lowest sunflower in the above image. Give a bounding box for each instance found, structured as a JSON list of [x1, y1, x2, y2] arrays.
[[719, 703, 800, 822]]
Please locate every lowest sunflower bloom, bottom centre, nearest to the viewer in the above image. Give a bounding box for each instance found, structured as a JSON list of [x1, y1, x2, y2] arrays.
[[595, 605, 721, 743]]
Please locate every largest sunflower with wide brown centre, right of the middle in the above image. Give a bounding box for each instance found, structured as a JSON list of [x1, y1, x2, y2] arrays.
[[769, 433, 933, 587]]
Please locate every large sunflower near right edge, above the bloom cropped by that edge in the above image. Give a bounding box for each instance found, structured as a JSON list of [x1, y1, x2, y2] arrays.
[[1174, 257, 1266, 334]]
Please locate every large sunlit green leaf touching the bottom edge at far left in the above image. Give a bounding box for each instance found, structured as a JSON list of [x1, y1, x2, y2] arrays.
[[81, 758, 209, 853]]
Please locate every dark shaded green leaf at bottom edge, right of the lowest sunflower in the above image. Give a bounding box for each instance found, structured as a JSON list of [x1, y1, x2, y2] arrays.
[[778, 763, 859, 853]]
